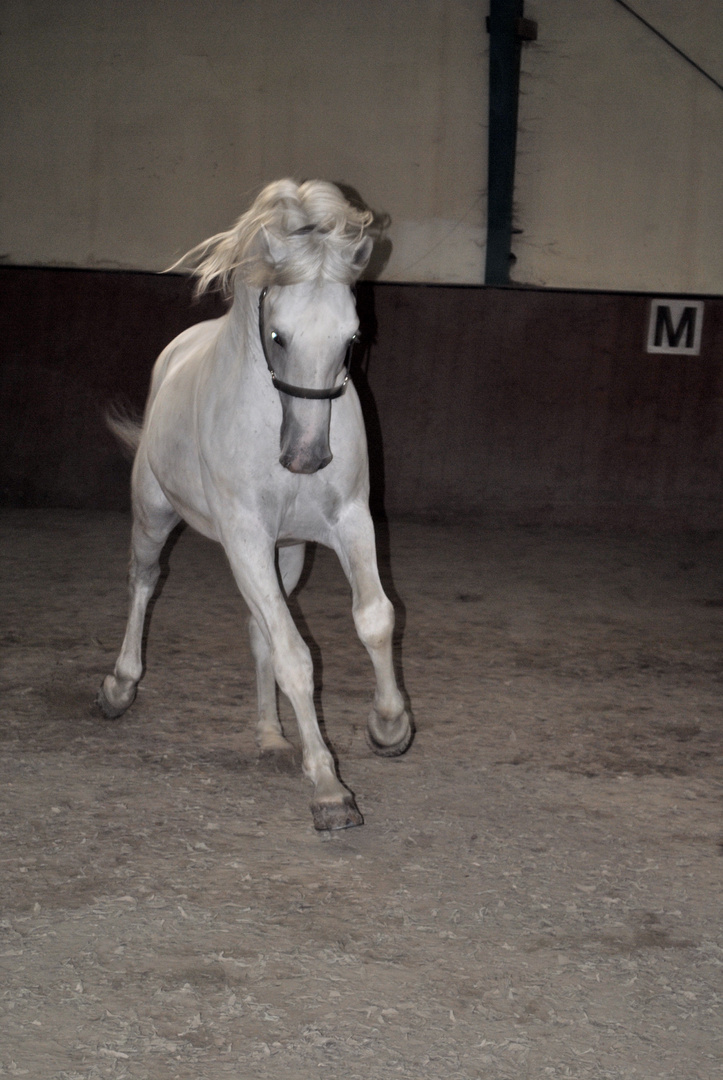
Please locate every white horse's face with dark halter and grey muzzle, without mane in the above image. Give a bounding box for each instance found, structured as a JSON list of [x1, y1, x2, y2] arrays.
[[259, 281, 359, 473]]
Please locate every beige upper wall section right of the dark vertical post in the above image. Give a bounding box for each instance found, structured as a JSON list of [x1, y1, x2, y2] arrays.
[[512, 0, 723, 294]]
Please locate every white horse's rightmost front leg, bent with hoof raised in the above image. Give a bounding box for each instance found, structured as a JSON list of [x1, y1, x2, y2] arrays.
[[335, 505, 414, 757]]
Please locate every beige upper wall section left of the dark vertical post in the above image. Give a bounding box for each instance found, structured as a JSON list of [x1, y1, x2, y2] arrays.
[[0, 0, 487, 281]]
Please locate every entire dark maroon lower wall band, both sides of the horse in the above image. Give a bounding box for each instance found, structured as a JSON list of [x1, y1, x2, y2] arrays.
[[0, 268, 723, 528]]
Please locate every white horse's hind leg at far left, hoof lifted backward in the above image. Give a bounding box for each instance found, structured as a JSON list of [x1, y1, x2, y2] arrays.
[[97, 479, 179, 719]]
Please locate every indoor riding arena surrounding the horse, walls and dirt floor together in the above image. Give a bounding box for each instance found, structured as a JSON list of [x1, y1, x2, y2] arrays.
[[0, 0, 723, 1080]]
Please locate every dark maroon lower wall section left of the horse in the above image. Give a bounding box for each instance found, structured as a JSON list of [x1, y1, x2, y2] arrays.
[[0, 268, 224, 509]]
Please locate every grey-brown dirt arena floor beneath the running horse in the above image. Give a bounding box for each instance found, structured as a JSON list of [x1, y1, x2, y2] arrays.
[[0, 511, 723, 1080]]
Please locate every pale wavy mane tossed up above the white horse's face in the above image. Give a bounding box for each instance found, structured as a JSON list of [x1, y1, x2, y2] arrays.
[[171, 179, 373, 295]]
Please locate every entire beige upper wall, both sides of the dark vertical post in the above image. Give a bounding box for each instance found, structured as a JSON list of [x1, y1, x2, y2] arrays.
[[0, 0, 723, 293]]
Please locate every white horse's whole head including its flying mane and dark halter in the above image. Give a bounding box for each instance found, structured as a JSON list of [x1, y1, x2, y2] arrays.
[[176, 179, 374, 473]]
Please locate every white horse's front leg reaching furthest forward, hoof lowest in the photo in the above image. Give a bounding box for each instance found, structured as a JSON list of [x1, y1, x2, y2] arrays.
[[224, 534, 362, 829]]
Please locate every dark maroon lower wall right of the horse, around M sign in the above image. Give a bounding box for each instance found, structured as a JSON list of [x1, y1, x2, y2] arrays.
[[360, 285, 723, 528]]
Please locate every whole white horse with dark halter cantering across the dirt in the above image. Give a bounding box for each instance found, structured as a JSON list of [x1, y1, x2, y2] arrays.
[[98, 180, 412, 829]]
